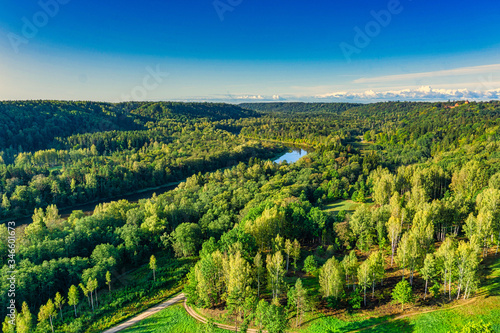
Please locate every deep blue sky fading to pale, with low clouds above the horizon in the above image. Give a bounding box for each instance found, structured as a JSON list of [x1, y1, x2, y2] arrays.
[[0, 0, 500, 102]]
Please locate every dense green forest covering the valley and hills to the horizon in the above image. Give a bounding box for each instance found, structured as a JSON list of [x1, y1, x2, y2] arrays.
[[0, 101, 500, 332]]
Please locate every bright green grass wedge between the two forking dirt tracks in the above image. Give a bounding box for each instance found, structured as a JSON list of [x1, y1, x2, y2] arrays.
[[122, 303, 228, 333]]
